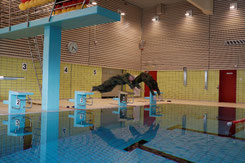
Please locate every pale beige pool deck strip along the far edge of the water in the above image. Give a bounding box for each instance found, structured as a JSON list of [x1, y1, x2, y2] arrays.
[[0, 98, 245, 115]]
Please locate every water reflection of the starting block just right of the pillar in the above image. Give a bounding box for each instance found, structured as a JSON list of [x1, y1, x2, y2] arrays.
[[69, 110, 94, 127]]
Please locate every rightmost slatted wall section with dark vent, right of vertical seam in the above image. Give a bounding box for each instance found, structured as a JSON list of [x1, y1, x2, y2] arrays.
[[210, 0, 245, 69]]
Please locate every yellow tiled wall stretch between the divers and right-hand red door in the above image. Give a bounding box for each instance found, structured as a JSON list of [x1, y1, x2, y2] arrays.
[[157, 70, 219, 101]]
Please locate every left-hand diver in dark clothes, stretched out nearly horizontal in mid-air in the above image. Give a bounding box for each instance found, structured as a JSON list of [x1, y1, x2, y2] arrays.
[[91, 73, 135, 93]]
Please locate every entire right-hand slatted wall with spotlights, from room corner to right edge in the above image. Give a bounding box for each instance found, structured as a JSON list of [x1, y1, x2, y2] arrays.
[[142, 0, 245, 70]]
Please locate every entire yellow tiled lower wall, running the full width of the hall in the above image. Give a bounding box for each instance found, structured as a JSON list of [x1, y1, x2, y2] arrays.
[[0, 56, 245, 103]]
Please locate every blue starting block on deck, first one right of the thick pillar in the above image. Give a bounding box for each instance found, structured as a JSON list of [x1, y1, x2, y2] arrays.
[[69, 91, 94, 109]]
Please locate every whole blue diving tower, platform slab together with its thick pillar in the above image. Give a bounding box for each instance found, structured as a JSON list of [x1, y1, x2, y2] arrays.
[[0, 6, 120, 111]]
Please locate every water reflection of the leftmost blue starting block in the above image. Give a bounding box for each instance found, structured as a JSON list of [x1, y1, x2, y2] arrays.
[[2, 114, 32, 136]]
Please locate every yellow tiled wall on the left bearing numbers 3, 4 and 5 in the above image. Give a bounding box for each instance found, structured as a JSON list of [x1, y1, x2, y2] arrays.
[[0, 56, 102, 100]]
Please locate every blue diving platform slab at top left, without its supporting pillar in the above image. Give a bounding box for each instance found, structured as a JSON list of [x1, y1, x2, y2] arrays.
[[0, 6, 120, 40]]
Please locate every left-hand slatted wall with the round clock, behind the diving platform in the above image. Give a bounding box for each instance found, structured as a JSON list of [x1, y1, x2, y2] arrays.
[[0, 0, 142, 70]]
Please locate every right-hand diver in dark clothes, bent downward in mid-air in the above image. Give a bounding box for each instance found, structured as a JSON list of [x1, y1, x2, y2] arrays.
[[133, 72, 161, 96]]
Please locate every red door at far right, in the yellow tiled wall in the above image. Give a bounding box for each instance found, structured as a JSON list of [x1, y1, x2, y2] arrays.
[[219, 70, 236, 103]]
